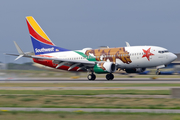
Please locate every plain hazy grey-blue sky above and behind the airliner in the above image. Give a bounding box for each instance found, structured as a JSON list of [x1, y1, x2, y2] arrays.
[[0, 0, 180, 63]]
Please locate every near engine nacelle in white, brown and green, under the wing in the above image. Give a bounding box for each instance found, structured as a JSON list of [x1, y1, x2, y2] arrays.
[[94, 62, 116, 73]]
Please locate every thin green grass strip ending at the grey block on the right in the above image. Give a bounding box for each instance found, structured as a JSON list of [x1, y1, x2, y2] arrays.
[[0, 90, 170, 95]]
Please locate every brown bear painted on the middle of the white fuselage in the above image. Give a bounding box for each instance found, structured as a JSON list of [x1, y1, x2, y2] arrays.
[[85, 47, 132, 64]]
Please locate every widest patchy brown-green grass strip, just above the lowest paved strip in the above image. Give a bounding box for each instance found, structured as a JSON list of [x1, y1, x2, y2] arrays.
[[0, 91, 180, 109]]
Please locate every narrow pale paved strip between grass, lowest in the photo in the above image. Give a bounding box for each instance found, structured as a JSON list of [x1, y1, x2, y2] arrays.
[[0, 107, 180, 113]]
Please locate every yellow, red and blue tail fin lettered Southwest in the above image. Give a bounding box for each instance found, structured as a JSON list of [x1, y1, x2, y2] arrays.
[[26, 16, 69, 55]]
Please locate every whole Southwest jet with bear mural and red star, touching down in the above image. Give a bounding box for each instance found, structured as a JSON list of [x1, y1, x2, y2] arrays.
[[5, 16, 177, 80]]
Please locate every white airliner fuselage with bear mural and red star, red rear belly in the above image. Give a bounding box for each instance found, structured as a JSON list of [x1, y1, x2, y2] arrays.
[[34, 46, 177, 71]]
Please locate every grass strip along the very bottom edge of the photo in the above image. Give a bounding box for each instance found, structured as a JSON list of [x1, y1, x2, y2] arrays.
[[0, 111, 180, 120]]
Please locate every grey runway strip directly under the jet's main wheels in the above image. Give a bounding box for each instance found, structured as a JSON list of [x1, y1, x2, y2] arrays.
[[0, 78, 180, 83]]
